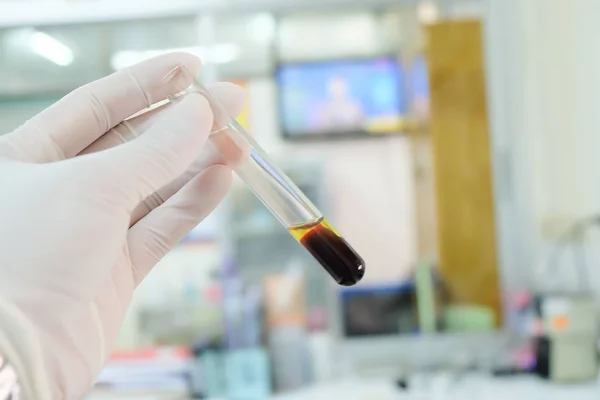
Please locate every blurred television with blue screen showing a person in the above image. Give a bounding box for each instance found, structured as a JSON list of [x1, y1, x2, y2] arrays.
[[276, 57, 408, 139]]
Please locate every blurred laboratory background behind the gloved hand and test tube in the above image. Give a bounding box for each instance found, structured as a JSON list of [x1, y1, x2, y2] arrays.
[[0, 0, 600, 400]]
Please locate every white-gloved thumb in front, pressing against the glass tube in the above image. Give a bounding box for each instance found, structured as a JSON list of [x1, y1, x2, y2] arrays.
[[78, 93, 213, 212]]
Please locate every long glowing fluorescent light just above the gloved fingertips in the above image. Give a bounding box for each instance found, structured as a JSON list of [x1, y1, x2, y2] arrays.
[[110, 43, 239, 70]]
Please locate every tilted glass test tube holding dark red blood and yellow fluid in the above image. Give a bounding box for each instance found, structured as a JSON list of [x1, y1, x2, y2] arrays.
[[165, 66, 365, 286]]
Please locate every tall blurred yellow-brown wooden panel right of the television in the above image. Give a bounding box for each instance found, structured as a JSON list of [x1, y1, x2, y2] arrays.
[[427, 21, 501, 319]]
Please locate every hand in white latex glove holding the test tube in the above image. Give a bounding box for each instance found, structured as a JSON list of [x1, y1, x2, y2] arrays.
[[0, 54, 243, 399]]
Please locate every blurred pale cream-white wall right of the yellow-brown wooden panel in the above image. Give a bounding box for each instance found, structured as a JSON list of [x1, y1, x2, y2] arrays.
[[486, 0, 600, 293]]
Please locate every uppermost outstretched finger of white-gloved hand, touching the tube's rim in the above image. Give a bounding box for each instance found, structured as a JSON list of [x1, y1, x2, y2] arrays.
[[0, 53, 201, 163]]
